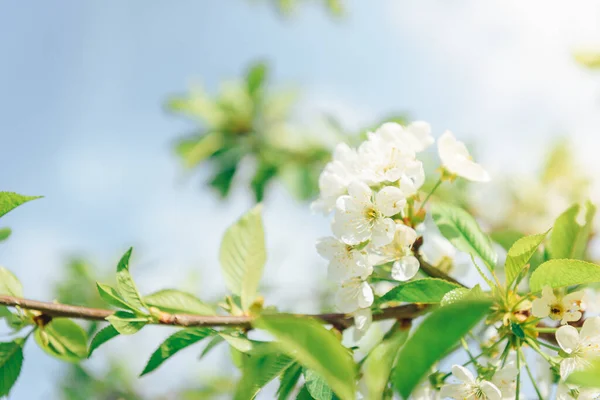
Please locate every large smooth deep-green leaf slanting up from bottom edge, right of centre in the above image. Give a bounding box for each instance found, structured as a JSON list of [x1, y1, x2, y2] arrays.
[[393, 301, 491, 399]]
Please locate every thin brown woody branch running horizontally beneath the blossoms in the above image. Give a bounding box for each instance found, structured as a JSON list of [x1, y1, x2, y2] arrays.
[[0, 296, 428, 329]]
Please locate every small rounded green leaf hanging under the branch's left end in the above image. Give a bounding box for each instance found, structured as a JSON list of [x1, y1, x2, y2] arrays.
[[34, 318, 88, 363]]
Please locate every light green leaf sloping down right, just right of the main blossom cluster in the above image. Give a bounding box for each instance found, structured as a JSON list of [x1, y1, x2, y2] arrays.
[[431, 203, 498, 271]]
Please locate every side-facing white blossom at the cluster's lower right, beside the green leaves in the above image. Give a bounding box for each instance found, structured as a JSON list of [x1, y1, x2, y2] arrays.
[[370, 224, 420, 281]]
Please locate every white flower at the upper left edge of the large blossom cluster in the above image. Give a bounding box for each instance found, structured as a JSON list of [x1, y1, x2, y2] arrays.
[[311, 143, 358, 214]]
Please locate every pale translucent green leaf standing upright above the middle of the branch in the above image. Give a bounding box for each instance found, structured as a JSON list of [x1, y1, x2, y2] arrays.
[[220, 204, 267, 310]]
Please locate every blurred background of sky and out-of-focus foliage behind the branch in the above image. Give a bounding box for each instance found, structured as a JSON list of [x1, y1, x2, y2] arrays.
[[0, 0, 600, 399]]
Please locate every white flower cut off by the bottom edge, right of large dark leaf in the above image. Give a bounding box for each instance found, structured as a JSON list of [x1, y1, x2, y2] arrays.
[[440, 365, 502, 400]]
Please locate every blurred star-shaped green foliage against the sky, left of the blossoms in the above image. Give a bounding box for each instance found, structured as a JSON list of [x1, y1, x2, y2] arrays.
[[167, 63, 330, 202]]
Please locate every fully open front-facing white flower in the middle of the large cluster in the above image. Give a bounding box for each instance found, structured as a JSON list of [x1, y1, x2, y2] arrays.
[[331, 181, 406, 246]]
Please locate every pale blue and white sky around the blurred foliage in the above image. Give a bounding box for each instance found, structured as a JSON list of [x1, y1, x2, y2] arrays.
[[0, 0, 600, 399]]
